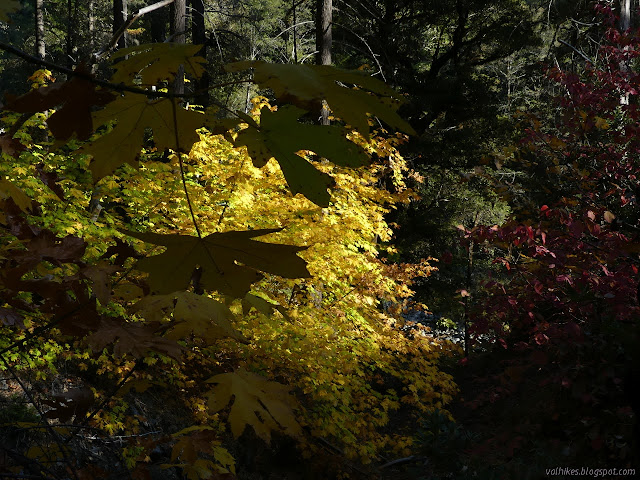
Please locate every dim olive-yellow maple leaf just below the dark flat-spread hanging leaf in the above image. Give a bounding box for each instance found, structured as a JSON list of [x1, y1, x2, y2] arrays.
[[132, 292, 247, 344]]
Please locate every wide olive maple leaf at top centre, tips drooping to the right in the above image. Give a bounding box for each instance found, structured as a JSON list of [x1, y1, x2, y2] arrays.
[[226, 60, 415, 136]]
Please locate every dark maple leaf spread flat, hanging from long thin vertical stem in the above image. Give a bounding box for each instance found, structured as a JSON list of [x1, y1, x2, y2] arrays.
[[124, 228, 310, 298]]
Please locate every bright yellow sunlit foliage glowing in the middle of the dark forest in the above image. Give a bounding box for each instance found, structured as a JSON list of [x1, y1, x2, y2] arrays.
[[106, 100, 456, 462]]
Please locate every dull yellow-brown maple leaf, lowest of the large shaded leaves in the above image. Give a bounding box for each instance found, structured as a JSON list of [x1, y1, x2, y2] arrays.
[[207, 369, 302, 443]]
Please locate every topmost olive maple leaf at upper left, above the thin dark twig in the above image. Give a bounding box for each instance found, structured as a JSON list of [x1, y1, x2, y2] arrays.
[[111, 43, 207, 85]]
